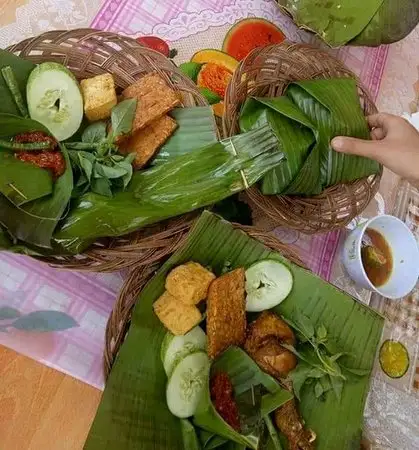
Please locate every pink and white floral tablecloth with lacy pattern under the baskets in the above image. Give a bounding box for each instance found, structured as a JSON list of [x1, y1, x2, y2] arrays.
[[0, 0, 414, 387]]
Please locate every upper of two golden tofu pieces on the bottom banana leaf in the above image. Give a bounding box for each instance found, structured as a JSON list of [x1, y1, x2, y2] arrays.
[[166, 262, 215, 305]]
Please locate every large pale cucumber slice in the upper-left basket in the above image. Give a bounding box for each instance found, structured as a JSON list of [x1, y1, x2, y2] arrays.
[[26, 62, 83, 141]]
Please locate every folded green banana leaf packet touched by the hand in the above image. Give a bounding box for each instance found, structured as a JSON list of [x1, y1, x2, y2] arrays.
[[240, 78, 380, 195]]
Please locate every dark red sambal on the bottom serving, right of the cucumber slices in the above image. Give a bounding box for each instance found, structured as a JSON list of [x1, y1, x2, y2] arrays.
[[210, 372, 240, 431]]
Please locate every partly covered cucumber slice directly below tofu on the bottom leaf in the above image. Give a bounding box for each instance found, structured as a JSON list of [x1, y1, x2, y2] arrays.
[[160, 327, 207, 377]]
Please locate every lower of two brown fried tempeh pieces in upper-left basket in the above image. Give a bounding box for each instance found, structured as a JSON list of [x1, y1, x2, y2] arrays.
[[119, 116, 177, 169]]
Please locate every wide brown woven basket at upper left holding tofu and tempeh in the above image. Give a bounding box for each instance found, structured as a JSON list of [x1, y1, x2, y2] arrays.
[[7, 29, 207, 272]]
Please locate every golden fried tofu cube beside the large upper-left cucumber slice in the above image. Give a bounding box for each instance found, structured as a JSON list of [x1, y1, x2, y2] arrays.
[[80, 73, 117, 122]]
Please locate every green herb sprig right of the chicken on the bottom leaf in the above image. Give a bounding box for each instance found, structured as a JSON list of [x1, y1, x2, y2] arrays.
[[282, 311, 369, 401]]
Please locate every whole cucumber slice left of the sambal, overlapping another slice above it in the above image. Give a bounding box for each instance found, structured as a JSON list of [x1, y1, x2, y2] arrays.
[[166, 351, 210, 419]]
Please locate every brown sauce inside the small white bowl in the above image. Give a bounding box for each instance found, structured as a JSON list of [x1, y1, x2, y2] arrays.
[[361, 228, 393, 287]]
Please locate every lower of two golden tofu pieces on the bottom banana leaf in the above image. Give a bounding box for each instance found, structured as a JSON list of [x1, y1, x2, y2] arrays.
[[153, 291, 202, 336]]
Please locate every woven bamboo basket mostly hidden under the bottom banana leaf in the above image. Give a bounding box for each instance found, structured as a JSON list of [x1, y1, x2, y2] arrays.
[[103, 221, 305, 380]]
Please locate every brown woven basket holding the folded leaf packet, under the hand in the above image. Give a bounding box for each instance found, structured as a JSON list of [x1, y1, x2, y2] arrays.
[[223, 42, 381, 234]]
